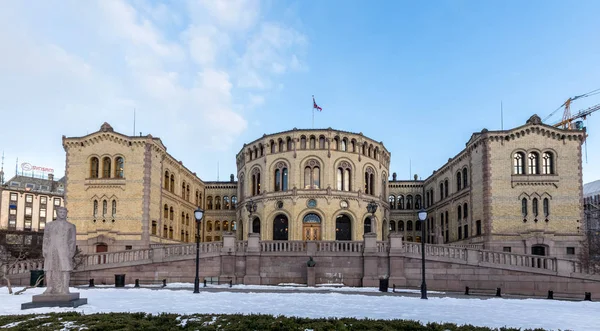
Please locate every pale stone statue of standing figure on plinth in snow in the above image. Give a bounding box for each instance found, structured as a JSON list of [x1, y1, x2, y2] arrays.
[[21, 207, 87, 309]]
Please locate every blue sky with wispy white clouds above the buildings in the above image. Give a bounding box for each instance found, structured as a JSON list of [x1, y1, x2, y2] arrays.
[[0, 0, 600, 182]]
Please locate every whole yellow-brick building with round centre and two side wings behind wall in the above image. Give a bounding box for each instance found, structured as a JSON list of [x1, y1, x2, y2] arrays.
[[63, 115, 586, 258]]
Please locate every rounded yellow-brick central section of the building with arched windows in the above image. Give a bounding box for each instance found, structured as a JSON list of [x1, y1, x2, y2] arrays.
[[236, 128, 390, 240]]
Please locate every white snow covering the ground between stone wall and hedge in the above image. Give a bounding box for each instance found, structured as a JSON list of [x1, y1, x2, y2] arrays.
[[0, 284, 600, 331]]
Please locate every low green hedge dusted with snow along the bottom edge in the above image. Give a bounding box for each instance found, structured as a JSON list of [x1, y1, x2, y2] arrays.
[[0, 312, 556, 331]]
